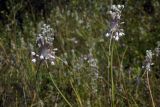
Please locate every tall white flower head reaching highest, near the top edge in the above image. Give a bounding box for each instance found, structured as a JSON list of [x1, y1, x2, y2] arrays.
[[106, 5, 125, 41]]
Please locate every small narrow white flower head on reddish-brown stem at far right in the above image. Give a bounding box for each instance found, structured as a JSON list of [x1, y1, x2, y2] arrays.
[[142, 50, 154, 71]]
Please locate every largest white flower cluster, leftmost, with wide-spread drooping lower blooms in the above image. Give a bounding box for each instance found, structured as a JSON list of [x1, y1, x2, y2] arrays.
[[31, 24, 57, 65]]
